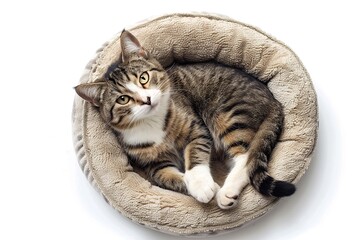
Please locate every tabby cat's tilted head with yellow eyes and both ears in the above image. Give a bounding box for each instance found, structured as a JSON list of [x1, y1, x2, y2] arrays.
[[75, 31, 170, 130]]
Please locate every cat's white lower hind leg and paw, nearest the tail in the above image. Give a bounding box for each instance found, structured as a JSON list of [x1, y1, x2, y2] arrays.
[[216, 153, 249, 209]]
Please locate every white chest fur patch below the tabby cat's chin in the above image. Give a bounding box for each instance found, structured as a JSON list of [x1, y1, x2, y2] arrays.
[[122, 117, 165, 145]]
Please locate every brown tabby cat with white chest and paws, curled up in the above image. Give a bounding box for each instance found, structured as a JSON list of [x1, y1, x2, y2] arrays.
[[75, 30, 295, 209]]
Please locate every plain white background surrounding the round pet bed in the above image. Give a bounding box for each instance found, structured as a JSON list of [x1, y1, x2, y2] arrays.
[[0, 0, 360, 240]]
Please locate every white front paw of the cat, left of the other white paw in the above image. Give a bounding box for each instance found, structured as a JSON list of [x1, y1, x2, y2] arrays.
[[184, 165, 219, 203]]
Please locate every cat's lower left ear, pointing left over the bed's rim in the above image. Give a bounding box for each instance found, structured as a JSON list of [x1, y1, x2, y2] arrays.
[[75, 83, 107, 107]]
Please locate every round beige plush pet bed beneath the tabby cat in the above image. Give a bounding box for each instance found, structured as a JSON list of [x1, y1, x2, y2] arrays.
[[73, 14, 318, 235]]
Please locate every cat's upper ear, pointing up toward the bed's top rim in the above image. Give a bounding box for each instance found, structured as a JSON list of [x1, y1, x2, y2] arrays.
[[120, 30, 149, 62]]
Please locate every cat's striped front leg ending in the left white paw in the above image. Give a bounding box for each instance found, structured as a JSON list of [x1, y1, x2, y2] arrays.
[[184, 139, 219, 203]]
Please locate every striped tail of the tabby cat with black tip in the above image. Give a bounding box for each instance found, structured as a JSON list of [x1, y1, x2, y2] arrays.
[[247, 103, 296, 197]]
